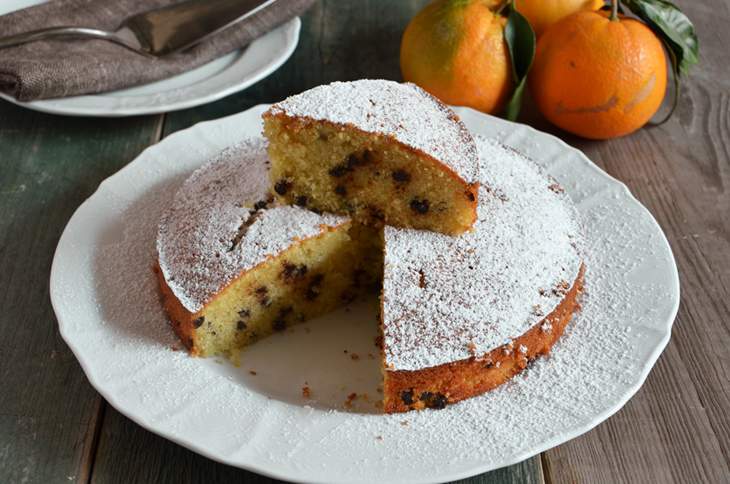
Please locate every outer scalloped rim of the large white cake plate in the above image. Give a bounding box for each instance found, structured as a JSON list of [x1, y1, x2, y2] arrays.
[[50, 104, 680, 483]]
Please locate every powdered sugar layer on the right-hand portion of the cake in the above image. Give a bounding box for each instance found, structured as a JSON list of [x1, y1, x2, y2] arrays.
[[383, 138, 581, 370]]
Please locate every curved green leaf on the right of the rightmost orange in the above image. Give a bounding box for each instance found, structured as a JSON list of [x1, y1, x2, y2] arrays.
[[623, 0, 699, 76]]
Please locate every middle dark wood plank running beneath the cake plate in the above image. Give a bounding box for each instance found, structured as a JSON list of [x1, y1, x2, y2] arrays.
[[86, 0, 543, 484]]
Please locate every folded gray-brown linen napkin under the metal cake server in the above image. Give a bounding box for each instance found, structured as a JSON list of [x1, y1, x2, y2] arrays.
[[0, 0, 315, 101]]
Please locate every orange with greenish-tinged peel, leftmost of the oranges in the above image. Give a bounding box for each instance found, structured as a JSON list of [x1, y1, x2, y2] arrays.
[[400, 0, 513, 113]]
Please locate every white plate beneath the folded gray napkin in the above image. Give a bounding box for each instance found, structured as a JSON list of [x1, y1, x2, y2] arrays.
[[0, 0, 301, 117]]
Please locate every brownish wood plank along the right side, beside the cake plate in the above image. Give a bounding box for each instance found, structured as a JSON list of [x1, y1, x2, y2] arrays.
[[531, 1, 730, 483]]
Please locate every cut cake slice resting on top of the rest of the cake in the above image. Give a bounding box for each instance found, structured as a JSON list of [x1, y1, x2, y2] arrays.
[[263, 80, 478, 234]]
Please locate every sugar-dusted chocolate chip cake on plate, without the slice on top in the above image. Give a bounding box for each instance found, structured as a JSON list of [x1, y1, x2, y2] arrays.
[[157, 138, 584, 413]]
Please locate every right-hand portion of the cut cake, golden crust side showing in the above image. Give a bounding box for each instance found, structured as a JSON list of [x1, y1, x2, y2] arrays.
[[381, 138, 583, 412]]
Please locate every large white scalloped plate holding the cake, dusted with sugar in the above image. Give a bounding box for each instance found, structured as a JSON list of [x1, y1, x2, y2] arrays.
[[50, 106, 679, 483]]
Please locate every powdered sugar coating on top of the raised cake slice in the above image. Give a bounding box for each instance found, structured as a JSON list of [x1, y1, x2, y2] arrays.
[[270, 79, 478, 183]]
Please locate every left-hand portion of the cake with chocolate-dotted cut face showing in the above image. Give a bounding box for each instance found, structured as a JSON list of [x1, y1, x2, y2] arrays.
[[157, 139, 382, 356]]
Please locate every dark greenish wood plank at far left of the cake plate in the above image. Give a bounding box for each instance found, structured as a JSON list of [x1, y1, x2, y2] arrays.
[[0, 102, 159, 483]]
